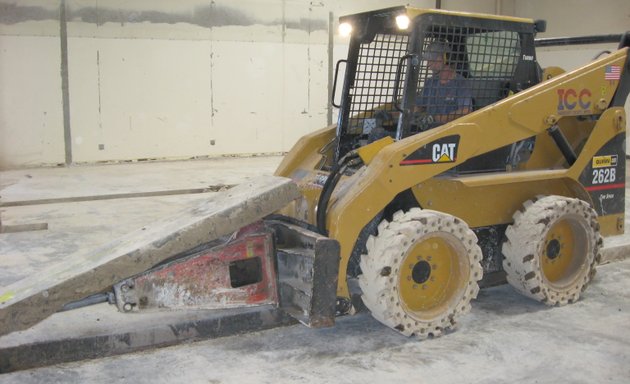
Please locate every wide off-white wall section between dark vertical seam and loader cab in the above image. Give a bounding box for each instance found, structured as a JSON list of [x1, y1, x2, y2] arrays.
[[63, 1, 336, 162]]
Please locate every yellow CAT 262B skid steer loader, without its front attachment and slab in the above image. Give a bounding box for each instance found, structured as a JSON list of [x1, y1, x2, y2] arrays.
[[277, 8, 630, 338]]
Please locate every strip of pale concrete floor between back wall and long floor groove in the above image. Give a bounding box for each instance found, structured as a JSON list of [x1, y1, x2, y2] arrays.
[[0, 156, 282, 207]]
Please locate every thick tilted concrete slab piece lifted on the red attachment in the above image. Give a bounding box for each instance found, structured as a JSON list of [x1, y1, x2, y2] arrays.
[[0, 176, 300, 335]]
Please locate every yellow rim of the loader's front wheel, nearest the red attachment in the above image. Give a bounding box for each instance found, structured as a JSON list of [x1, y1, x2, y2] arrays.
[[398, 236, 469, 318]]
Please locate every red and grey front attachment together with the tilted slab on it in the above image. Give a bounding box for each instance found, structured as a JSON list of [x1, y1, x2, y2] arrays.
[[0, 177, 339, 335]]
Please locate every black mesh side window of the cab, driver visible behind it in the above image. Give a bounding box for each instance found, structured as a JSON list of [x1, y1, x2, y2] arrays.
[[416, 26, 521, 125]]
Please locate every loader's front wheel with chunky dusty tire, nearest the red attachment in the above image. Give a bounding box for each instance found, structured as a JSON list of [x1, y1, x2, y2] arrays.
[[359, 208, 483, 339]]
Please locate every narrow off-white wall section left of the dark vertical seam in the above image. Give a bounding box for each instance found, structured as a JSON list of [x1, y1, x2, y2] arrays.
[[0, 36, 64, 166]]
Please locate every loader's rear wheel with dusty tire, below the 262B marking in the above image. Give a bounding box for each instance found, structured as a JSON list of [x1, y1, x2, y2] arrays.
[[503, 196, 602, 305]]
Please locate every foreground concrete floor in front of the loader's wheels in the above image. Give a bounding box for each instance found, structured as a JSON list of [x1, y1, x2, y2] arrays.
[[0, 260, 630, 384]]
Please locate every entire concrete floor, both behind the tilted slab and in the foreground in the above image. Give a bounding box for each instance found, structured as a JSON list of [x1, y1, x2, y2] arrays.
[[0, 157, 630, 383]]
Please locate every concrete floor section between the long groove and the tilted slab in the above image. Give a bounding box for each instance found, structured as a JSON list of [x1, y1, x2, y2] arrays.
[[0, 193, 213, 286]]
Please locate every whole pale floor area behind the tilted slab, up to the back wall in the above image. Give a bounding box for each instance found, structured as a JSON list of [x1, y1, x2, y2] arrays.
[[0, 156, 282, 287]]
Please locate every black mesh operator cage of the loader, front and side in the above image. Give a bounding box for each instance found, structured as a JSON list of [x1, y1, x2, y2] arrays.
[[338, 13, 540, 171]]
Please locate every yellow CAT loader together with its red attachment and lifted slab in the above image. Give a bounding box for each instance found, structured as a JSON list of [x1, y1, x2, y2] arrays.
[[0, 7, 630, 338]]
